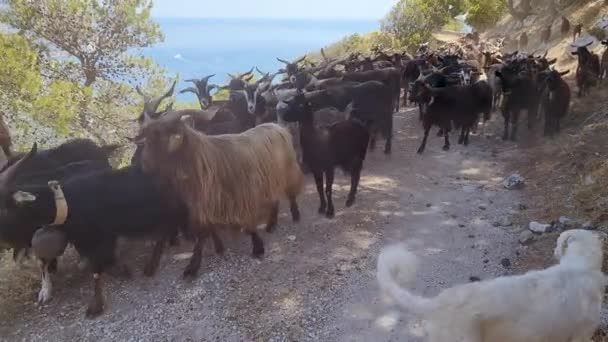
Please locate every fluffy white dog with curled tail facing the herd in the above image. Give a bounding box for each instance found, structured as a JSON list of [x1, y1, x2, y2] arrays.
[[377, 230, 607, 342]]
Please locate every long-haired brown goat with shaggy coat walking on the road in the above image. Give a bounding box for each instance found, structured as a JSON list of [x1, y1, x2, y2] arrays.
[[140, 113, 304, 276]]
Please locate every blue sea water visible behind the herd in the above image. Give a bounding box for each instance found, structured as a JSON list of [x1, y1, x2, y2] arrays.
[[144, 18, 379, 99]]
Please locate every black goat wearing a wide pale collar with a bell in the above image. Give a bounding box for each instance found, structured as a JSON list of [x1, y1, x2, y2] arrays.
[[0, 145, 195, 316]]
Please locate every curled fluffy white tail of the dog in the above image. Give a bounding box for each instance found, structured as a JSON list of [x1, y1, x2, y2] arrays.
[[376, 244, 436, 315]]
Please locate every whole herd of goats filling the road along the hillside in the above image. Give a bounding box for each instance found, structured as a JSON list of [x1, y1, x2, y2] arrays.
[[0, 27, 603, 316]]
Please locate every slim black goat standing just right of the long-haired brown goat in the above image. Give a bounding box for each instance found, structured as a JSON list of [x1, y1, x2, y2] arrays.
[[281, 94, 370, 218]]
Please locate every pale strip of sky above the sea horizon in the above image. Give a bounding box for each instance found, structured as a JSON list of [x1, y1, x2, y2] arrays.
[[153, 0, 397, 20]]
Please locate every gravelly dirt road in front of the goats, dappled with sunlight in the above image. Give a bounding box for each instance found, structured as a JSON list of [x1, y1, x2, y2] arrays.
[[0, 110, 519, 341]]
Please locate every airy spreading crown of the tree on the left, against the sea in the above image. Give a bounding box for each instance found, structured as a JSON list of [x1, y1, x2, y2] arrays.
[[0, 0, 163, 86]]
